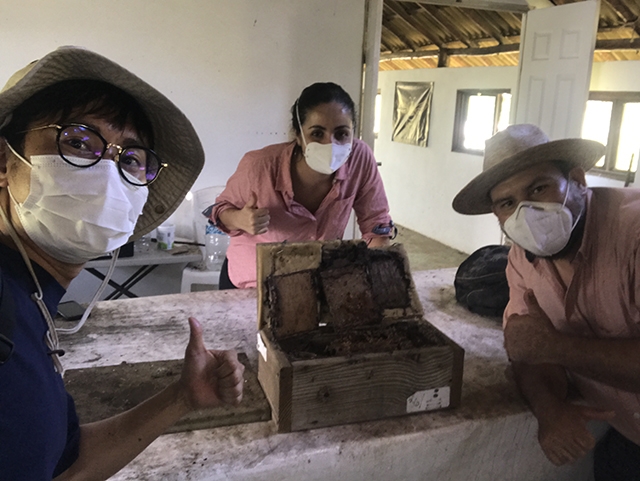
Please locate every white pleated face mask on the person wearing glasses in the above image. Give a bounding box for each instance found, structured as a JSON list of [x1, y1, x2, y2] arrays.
[[9, 155, 149, 264]]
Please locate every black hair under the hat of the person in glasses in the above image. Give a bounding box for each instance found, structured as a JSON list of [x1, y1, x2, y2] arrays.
[[0, 79, 154, 149]]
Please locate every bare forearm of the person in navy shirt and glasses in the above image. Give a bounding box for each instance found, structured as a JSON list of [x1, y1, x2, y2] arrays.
[[55, 383, 190, 481]]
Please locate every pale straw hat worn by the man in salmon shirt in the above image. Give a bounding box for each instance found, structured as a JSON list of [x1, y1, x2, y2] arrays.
[[453, 124, 605, 215]]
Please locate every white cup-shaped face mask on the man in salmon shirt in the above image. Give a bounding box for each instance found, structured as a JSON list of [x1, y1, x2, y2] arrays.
[[502, 184, 580, 257]]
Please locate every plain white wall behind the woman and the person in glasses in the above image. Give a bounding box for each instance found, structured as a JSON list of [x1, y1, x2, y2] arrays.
[[0, 0, 365, 300]]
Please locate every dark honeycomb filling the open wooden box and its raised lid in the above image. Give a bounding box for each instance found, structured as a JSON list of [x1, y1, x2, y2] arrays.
[[259, 241, 445, 348]]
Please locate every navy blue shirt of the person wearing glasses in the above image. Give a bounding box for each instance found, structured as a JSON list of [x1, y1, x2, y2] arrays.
[[0, 244, 80, 481]]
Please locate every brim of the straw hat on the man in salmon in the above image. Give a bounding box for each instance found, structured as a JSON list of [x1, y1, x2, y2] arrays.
[[452, 139, 605, 215]]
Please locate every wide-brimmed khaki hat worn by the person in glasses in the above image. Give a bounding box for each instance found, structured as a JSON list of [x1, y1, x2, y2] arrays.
[[0, 47, 204, 240]]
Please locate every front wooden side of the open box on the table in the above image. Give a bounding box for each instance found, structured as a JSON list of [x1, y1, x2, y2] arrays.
[[291, 345, 454, 431]]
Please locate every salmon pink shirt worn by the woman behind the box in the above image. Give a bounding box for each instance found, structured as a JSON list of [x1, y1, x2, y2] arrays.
[[210, 139, 391, 288]]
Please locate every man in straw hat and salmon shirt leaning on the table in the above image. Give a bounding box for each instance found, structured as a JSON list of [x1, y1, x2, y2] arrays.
[[453, 124, 640, 481]]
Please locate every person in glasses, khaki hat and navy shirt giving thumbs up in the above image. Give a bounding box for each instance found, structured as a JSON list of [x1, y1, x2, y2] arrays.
[[0, 47, 244, 481]]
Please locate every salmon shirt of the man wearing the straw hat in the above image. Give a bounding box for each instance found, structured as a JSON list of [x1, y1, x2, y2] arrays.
[[504, 188, 640, 444]]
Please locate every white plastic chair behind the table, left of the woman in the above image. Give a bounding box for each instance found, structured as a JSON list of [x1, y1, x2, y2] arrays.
[[180, 186, 224, 293]]
